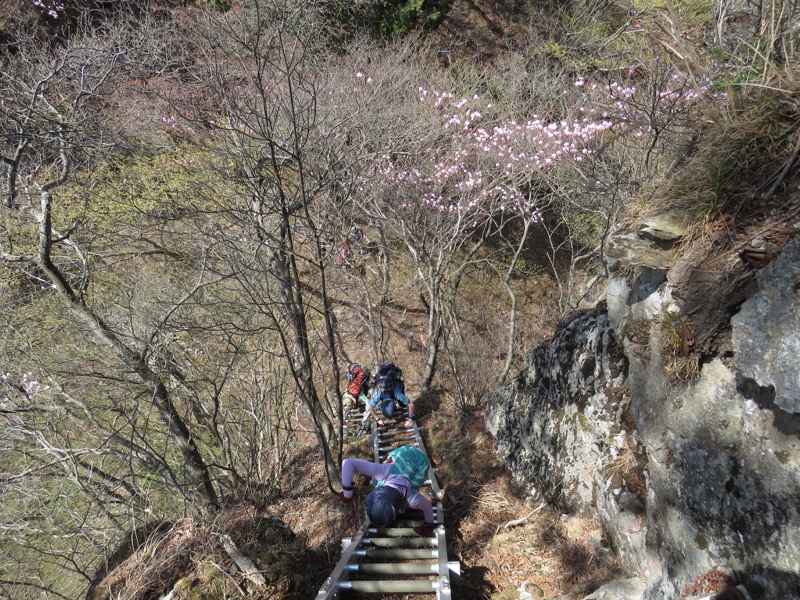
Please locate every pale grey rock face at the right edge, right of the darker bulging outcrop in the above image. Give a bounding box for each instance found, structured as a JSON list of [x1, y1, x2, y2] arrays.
[[626, 239, 800, 600]]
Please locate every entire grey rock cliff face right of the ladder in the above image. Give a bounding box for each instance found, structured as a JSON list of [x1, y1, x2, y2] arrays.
[[486, 225, 800, 600]]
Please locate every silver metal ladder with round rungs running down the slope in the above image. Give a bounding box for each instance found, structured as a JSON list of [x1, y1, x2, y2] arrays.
[[317, 413, 460, 600]]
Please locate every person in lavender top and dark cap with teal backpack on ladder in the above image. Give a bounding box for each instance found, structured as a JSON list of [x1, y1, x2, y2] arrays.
[[339, 446, 434, 537]]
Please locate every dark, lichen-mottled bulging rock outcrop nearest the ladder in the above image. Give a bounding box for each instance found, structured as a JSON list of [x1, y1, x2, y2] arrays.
[[486, 310, 650, 573]]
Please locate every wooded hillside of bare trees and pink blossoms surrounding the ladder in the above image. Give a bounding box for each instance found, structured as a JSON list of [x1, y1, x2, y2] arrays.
[[0, 0, 800, 600]]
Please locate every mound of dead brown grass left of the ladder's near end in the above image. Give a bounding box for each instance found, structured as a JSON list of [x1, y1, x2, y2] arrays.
[[91, 436, 344, 600]]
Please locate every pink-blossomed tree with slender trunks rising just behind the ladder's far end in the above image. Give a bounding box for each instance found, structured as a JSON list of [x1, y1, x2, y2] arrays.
[[348, 74, 612, 390]]
